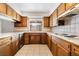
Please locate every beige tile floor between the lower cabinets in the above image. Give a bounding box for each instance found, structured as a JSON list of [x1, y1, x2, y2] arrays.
[[15, 44, 52, 56]]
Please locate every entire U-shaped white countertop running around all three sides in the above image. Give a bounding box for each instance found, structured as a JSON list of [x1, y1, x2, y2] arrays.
[[0, 31, 79, 46]]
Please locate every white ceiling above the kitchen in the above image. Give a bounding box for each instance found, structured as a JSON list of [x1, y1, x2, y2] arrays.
[[8, 3, 60, 18]]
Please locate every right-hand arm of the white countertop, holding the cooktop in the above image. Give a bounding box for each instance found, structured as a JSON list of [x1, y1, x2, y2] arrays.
[[47, 32, 79, 46]]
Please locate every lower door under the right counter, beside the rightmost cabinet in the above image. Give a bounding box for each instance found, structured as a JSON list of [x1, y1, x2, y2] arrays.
[[57, 44, 70, 56]]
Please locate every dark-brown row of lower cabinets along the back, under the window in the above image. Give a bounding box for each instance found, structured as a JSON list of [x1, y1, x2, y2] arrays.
[[24, 33, 47, 45]]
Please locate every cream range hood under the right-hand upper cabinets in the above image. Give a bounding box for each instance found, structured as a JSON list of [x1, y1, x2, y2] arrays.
[[58, 4, 79, 19]]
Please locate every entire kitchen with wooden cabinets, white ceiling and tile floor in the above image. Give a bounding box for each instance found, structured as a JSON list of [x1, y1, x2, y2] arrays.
[[0, 3, 79, 56]]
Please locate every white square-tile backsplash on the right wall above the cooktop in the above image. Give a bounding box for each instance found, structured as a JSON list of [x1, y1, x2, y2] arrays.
[[52, 15, 79, 35]]
